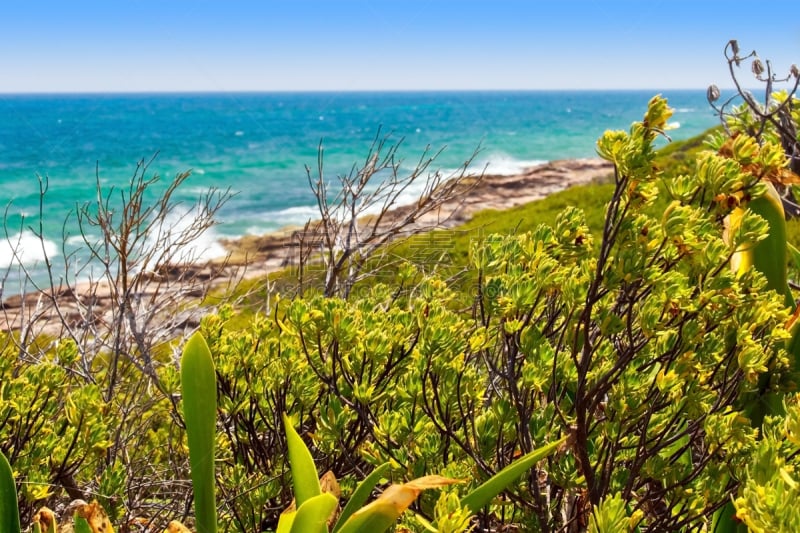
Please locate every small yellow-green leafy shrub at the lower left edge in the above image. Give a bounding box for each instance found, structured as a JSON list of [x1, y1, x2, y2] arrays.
[[0, 341, 120, 520]]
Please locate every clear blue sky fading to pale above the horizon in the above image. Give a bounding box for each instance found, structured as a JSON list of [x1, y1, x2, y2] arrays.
[[0, 0, 800, 93]]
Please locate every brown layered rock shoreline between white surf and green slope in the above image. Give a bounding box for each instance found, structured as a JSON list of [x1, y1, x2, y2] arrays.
[[0, 157, 614, 336]]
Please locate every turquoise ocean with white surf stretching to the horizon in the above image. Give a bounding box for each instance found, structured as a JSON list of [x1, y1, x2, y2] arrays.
[[0, 90, 718, 286]]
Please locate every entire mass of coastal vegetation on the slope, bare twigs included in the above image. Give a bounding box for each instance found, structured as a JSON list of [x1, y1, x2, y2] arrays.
[[0, 41, 800, 533]]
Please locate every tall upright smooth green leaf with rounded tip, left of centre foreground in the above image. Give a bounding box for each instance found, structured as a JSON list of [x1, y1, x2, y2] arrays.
[[181, 333, 217, 533]]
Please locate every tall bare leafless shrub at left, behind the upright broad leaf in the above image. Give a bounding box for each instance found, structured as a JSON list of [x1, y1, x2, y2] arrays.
[[0, 155, 241, 515]]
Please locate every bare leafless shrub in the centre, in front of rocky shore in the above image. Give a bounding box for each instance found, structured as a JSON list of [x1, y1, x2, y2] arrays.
[[293, 133, 483, 298]]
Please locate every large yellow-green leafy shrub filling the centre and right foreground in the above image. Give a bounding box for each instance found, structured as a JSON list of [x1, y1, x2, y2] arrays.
[[194, 98, 788, 531]]
